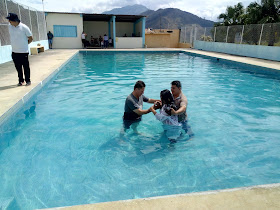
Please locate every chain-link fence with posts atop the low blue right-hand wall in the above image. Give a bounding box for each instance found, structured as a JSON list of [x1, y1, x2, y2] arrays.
[[180, 23, 280, 47]]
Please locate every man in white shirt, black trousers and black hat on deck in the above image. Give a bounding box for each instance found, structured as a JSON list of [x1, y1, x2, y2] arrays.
[[6, 13, 33, 86]]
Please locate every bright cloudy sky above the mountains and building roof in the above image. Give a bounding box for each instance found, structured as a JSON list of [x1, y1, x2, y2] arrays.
[[16, 0, 255, 21]]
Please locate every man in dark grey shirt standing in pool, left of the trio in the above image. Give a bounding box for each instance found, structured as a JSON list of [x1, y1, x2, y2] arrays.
[[123, 80, 158, 132]]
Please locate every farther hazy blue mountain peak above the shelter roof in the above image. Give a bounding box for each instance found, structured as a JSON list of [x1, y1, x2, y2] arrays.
[[102, 4, 149, 15]]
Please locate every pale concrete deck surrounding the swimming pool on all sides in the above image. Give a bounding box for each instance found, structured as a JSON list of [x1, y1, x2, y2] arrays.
[[0, 48, 280, 210]]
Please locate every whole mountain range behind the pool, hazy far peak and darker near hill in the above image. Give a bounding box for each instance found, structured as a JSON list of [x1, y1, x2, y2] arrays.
[[102, 4, 214, 29]]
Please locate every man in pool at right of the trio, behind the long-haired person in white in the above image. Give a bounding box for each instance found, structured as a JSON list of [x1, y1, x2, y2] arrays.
[[171, 80, 194, 137]]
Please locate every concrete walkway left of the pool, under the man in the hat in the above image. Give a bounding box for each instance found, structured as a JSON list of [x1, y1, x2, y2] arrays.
[[0, 50, 78, 122]]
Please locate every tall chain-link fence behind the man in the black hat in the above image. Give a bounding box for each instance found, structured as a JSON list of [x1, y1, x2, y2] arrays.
[[0, 0, 47, 46]]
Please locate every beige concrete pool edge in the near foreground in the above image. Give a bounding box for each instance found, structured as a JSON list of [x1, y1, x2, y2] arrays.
[[41, 184, 280, 210]]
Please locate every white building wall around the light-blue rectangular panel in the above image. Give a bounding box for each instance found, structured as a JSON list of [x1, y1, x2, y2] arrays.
[[46, 13, 83, 49]]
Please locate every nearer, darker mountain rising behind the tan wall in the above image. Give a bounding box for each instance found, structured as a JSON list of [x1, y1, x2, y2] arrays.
[[141, 8, 214, 29]]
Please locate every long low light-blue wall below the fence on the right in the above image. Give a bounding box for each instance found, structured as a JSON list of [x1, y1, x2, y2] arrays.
[[194, 40, 280, 61]]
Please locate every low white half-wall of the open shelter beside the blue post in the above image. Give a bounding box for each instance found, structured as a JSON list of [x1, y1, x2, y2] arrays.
[[116, 37, 142, 49]]
